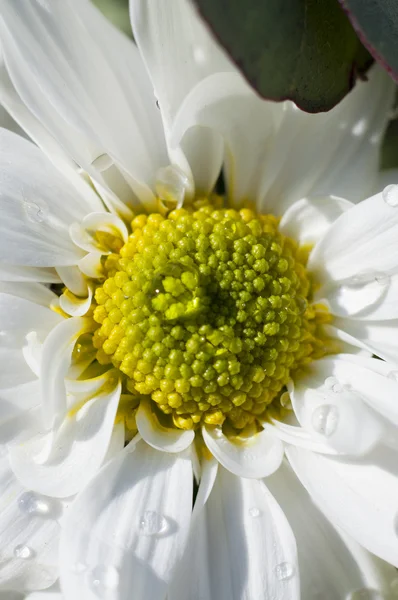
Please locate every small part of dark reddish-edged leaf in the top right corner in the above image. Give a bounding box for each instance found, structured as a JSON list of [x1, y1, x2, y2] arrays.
[[339, 0, 398, 80]]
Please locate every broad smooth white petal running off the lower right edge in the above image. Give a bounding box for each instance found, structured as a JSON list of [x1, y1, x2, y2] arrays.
[[287, 446, 398, 566]]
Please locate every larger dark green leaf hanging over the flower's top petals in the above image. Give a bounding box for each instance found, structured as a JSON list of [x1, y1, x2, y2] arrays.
[[195, 0, 372, 112]]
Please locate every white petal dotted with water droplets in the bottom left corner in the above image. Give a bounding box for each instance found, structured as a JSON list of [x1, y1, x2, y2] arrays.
[[0, 456, 62, 590]]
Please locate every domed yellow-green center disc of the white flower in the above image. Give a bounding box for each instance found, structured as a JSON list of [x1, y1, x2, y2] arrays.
[[93, 199, 330, 429]]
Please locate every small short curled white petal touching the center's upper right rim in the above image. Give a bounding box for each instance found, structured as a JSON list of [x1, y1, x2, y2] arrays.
[[279, 196, 352, 245]]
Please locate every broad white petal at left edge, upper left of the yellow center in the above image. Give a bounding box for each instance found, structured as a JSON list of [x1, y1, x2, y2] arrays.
[[0, 129, 84, 267]]
